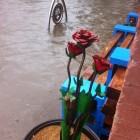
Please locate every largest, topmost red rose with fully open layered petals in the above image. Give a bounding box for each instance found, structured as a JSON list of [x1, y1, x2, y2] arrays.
[[72, 30, 100, 47]]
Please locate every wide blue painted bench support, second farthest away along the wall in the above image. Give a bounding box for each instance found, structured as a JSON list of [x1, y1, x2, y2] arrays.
[[113, 24, 136, 42]]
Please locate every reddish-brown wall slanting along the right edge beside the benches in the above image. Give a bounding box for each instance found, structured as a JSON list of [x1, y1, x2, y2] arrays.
[[109, 18, 140, 140]]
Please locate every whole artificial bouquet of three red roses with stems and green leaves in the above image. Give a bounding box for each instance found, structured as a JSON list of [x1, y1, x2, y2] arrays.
[[60, 30, 111, 140]]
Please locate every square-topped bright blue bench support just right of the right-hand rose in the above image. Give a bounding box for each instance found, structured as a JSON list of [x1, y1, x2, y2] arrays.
[[106, 47, 131, 86]]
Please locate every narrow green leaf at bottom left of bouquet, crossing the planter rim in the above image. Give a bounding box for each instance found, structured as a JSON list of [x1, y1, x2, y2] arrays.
[[61, 120, 70, 140]]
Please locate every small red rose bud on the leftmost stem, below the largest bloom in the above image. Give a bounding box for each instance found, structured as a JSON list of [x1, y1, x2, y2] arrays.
[[67, 42, 83, 57]]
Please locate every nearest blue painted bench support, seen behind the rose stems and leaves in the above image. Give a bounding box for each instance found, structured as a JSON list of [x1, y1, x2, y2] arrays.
[[61, 76, 106, 134]]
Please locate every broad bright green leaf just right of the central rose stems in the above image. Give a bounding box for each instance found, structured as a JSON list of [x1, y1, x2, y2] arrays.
[[76, 90, 93, 116]]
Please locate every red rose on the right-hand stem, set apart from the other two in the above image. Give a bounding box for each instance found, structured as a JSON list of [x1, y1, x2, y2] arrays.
[[93, 55, 112, 74]]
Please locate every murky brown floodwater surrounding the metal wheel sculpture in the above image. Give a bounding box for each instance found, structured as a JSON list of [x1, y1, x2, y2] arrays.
[[0, 0, 140, 140]]
